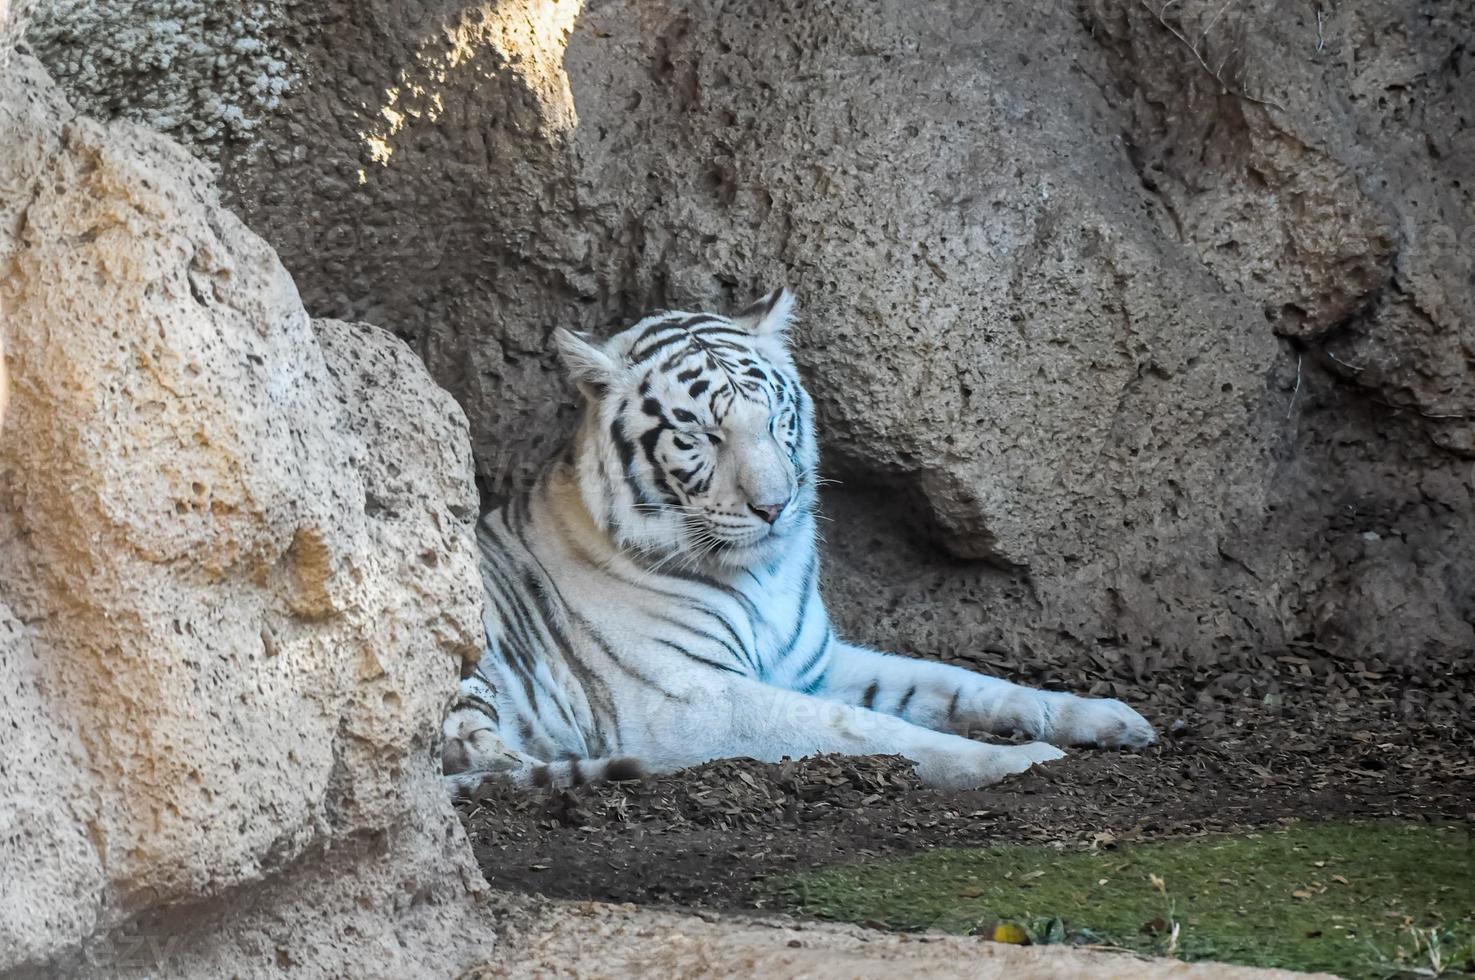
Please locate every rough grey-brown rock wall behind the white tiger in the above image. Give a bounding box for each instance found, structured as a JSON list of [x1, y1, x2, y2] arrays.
[[31, 0, 1475, 694]]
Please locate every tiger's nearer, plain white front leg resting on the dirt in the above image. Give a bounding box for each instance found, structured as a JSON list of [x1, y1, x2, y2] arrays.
[[621, 676, 1063, 790]]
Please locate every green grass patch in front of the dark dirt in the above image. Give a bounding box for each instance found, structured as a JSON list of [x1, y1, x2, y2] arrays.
[[774, 824, 1475, 979]]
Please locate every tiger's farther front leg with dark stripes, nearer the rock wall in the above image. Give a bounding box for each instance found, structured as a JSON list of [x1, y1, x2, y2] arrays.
[[811, 642, 1158, 748]]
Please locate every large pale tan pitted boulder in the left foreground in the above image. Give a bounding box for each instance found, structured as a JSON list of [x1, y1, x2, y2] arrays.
[[0, 21, 490, 977]]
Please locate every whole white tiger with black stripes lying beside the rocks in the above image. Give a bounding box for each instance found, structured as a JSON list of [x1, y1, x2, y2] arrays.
[[443, 289, 1155, 788]]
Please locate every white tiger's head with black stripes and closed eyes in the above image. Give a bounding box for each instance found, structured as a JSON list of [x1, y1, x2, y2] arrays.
[[558, 288, 819, 568]]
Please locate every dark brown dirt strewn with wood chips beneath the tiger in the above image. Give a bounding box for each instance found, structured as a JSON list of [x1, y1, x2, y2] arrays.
[[459, 654, 1475, 909]]
